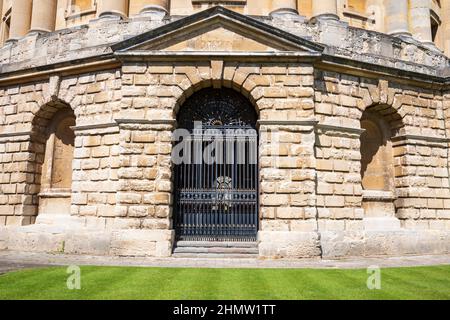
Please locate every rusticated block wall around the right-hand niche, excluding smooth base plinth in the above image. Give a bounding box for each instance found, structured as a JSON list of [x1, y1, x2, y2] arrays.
[[316, 72, 450, 229]]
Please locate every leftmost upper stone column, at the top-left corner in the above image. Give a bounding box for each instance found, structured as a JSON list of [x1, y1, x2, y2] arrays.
[[8, 0, 32, 41]]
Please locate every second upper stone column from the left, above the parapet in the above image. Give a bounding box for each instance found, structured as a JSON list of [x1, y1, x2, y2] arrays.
[[30, 0, 57, 32]]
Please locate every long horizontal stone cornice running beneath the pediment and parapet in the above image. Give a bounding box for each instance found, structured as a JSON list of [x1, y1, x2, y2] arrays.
[[0, 52, 450, 90]]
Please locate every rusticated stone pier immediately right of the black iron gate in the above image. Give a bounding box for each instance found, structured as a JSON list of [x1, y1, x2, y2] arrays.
[[258, 120, 320, 258]]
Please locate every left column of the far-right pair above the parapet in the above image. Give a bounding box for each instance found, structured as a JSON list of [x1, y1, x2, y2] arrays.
[[385, 0, 411, 36]]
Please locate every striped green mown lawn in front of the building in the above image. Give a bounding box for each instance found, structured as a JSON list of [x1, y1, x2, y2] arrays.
[[0, 266, 450, 300]]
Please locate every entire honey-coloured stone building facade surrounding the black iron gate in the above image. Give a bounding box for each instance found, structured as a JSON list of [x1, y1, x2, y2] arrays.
[[0, 0, 450, 258]]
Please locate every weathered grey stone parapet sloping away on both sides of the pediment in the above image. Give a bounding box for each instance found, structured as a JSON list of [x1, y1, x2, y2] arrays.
[[0, 7, 448, 75]]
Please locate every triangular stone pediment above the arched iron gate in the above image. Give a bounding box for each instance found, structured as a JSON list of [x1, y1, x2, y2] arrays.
[[112, 7, 324, 54]]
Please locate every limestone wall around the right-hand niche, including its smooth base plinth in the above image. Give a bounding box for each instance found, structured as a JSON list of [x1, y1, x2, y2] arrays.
[[315, 71, 450, 257]]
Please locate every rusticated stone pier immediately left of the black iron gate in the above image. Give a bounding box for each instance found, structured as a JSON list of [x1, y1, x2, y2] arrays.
[[112, 119, 174, 257]]
